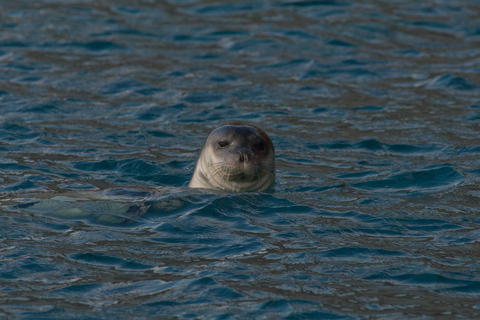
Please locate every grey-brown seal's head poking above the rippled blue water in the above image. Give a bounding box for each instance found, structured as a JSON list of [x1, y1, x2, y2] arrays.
[[188, 124, 275, 192]]
